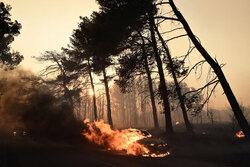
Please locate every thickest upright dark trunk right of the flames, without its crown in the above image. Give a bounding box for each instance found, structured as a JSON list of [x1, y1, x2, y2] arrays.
[[148, 12, 173, 134]]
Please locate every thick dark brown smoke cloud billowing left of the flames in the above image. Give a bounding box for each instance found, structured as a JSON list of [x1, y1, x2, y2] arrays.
[[0, 68, 81, 139]]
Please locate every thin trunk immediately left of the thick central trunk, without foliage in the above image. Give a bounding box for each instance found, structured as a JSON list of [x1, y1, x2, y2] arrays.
[[141, 33, 159, 129]]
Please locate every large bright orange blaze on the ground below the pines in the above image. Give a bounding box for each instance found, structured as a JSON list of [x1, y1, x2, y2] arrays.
[[82, 119, 170, 157]]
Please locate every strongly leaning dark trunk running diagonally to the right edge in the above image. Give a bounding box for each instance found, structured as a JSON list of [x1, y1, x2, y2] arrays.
[[169, 0, 250, 138]]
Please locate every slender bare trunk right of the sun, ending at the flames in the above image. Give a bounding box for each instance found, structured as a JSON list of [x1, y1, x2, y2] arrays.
[[102, 68, 113, 127]]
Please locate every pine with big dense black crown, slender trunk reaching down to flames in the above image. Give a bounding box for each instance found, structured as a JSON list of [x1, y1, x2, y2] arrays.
[[78, 0, 154, 126]]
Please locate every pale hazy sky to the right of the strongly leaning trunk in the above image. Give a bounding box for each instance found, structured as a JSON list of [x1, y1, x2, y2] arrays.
[[176, 0, 250, 107]]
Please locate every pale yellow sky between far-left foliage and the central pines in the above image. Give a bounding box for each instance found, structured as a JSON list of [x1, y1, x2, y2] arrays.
[[3, 0, 98, 72]]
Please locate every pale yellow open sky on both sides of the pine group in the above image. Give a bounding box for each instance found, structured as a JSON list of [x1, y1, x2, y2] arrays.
[[3, 0, 250, 107]]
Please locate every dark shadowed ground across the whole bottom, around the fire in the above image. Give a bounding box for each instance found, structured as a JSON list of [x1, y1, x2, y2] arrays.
[[0, 124, 250, 167]]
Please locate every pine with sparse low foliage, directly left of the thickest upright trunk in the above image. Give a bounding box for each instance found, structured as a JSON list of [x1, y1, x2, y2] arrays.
[[116, 32, 159, 128]]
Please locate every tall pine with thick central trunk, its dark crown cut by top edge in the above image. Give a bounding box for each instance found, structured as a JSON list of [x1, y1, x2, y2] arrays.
[[94, 0, 176, 134]]
